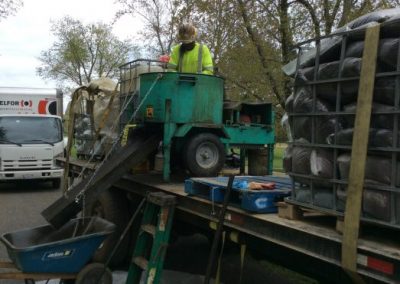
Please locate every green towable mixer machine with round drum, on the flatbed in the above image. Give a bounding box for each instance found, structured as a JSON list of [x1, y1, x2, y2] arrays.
[[120, 61, 275, 181]]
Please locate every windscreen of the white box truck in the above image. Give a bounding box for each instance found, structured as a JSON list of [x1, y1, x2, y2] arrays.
[[0, 116, 63, 144]]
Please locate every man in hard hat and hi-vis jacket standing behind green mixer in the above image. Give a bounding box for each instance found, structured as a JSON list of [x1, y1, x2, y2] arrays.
[[168, 24, 214, 75]]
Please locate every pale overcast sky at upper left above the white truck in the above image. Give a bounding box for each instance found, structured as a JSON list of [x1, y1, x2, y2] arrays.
[[0, 0, 142, 88]]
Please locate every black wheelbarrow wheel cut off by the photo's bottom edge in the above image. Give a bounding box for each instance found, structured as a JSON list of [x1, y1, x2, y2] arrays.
[[75, 263, 112, 284]]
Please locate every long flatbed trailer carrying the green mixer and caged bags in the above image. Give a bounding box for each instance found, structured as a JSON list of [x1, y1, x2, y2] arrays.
[[58, 156, 400, 283]]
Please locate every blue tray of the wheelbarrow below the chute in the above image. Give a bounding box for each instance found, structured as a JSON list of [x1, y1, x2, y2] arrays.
[[1, 217, 115, 273]]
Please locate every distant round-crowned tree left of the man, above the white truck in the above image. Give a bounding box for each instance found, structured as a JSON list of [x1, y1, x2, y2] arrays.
[[36, 17, 138, 87]]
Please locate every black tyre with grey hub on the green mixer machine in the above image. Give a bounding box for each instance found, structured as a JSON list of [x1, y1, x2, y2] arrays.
[[184, 133, 225, 177]]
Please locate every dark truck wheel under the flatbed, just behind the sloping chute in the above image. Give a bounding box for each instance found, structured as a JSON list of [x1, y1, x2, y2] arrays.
[[84, 188, 130, 267]]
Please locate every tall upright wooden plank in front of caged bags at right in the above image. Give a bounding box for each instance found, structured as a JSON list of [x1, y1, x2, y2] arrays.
[[341, 24, 380, 282]]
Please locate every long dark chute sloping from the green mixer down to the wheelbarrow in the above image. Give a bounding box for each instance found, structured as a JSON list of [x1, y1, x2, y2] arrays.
[[42, 130, 161, 228]]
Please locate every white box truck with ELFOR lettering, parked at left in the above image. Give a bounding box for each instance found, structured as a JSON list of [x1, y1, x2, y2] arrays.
[[0, 87, 64, 188]]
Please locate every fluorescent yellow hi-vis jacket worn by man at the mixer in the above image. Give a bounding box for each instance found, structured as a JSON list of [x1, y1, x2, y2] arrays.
[[168, 42, 213, 75]]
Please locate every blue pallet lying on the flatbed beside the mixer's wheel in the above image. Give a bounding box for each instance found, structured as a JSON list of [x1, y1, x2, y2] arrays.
[[185, 176, 292, 213]]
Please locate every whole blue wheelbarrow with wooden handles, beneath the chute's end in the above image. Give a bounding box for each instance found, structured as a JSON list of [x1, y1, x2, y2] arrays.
[[0, 217, 115, 284]]
